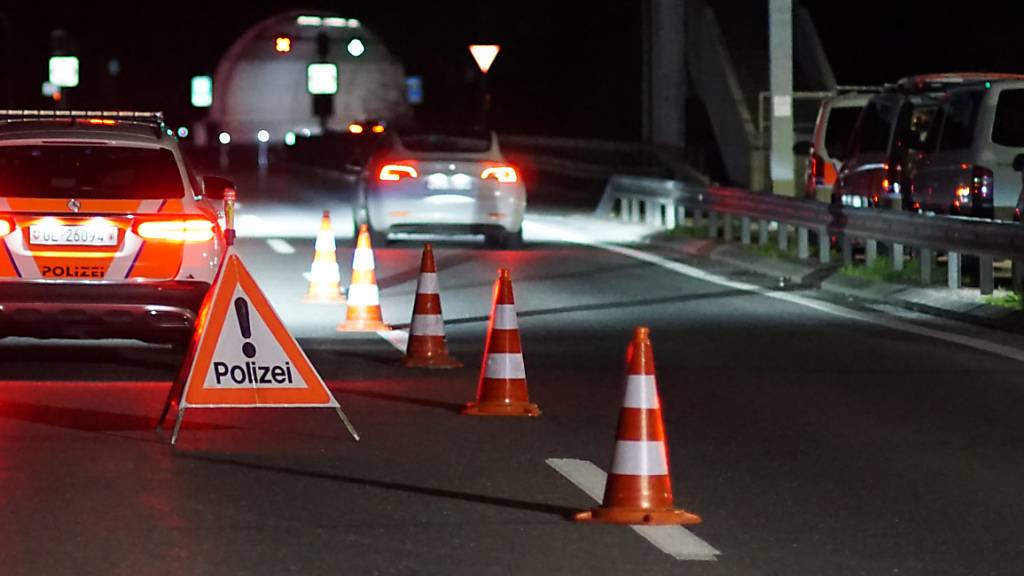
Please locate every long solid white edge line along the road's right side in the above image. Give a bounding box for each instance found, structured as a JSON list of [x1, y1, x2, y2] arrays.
[[535, 222, 1024, 362]]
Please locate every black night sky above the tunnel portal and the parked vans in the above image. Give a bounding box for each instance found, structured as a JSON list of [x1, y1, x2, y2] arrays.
[[0, 0, 1024, 138]]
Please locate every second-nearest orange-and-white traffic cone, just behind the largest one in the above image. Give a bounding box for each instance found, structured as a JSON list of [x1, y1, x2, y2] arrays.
[[462, 269, 541, 416]]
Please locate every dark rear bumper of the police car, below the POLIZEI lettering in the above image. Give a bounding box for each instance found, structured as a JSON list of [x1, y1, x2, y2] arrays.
[[0, 282, 210, 342]]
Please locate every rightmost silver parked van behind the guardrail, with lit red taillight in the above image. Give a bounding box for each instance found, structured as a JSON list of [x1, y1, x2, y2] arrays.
[[910, 76, 1024, 219]]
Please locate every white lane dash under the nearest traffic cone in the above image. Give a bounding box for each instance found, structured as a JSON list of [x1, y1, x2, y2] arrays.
[[545, 458, 722, 562]]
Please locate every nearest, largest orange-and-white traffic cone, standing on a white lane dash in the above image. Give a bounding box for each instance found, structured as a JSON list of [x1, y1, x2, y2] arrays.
[[575, 326, 700, 524]]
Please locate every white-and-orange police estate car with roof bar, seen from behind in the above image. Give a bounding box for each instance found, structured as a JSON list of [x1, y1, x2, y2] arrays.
[[0, 110, 233, 342]]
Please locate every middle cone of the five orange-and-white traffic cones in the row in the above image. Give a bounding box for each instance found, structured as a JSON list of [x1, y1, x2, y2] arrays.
[[402, 244, 462, 368]]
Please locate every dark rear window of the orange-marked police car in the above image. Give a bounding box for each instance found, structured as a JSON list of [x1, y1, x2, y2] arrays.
[[0, 145, 184, 199]]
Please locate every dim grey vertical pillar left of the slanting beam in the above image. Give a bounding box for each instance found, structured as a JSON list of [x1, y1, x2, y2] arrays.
[[643, 0, 686, 148]]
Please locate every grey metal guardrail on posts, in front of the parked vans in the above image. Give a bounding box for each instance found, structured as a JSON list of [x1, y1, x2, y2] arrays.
[[597, 175, 1024, 294]]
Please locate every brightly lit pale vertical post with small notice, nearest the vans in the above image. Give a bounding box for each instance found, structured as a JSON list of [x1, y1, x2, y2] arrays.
[[768, 0, 797, 196]]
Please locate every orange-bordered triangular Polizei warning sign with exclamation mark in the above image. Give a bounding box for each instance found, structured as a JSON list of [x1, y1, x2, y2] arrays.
[[180, 250, 339, 409]]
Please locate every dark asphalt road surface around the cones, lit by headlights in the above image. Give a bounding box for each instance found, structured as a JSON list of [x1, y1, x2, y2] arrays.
[[0, 163, 1024, 576]]
